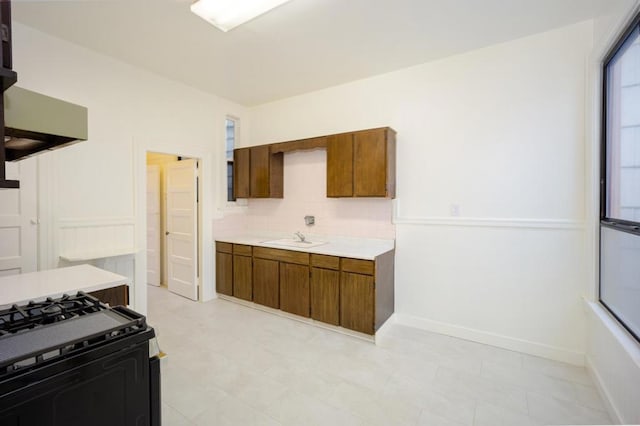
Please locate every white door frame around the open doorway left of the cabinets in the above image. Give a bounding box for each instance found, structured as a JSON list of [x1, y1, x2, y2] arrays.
[[131, 143, 220, 314]]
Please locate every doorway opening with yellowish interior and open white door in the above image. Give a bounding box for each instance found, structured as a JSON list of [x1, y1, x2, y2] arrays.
[[146, 152, 202, 300]]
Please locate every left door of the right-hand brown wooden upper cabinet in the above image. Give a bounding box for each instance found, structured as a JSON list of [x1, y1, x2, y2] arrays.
[[327, 133, 353, 197]]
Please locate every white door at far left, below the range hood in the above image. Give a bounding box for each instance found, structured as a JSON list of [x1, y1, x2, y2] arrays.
[[0, 158, 38, 276]]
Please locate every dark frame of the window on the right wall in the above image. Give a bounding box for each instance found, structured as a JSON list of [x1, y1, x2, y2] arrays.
[[598, 12, 640, 342]]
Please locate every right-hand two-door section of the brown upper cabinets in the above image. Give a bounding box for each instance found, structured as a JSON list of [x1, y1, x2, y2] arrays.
[[327, 127, 396, 198]]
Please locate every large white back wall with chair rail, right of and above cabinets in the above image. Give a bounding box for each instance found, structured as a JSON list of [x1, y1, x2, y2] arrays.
[[251, 22, 593, 364]]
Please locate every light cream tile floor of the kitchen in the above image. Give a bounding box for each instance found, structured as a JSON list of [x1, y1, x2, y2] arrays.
[[148, 287, 610, 426]]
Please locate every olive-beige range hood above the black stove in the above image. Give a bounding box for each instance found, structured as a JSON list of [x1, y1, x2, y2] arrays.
[[4, 86, 87, 161]]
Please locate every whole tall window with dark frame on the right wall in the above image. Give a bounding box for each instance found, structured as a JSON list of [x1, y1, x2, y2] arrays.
[[600, 16, 640, 340]]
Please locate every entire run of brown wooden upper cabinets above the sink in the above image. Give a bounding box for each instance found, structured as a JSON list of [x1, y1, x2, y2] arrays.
[[233, 127, 396, 198]]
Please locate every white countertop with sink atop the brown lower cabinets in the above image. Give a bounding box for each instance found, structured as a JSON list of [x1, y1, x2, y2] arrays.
[[216, 235, 395, 260]]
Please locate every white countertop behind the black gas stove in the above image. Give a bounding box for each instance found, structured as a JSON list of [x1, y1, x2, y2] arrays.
[[0, 265, 129, 306]]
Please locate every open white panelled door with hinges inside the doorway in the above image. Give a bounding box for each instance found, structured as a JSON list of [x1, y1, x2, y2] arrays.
[[165, 160, 198, 300]]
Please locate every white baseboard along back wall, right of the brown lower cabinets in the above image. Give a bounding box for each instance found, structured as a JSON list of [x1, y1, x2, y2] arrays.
[[394, 313, 585, 366]]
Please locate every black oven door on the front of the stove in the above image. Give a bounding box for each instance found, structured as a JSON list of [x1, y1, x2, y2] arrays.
[[0, 339, 155, 426]]
